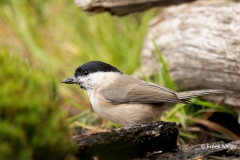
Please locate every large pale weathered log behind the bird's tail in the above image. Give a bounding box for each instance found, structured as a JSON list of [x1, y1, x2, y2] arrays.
[[139, 1, 240, 122]]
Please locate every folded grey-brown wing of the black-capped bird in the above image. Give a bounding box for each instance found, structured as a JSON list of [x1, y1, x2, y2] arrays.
[[102, 75, 185, 104]]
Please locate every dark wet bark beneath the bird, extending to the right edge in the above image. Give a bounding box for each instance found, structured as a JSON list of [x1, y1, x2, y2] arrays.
[[74, 122, 240, 160]]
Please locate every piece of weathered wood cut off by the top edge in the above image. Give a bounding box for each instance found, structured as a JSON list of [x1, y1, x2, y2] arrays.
[[75, 0, 195, 16]]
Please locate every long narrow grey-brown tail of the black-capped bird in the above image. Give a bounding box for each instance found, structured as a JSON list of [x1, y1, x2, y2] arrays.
[[177, 89, 232, 99]]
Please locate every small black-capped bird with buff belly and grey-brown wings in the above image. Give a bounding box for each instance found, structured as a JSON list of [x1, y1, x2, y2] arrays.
[[62, 61, 230, 127]]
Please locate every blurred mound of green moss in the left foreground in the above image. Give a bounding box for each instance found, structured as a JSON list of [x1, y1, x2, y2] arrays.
[[0, 48, 74, 160]]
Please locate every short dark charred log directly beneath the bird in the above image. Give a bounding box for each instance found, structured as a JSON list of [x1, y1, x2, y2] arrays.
[[74, 122, 178, 159]]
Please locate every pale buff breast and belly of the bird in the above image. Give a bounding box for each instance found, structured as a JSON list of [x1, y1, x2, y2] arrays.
[[87, 87, 171, 126]]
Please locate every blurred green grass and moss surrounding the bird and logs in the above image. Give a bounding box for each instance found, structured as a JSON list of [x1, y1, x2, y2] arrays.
[[0, 0, 240, 160]]
